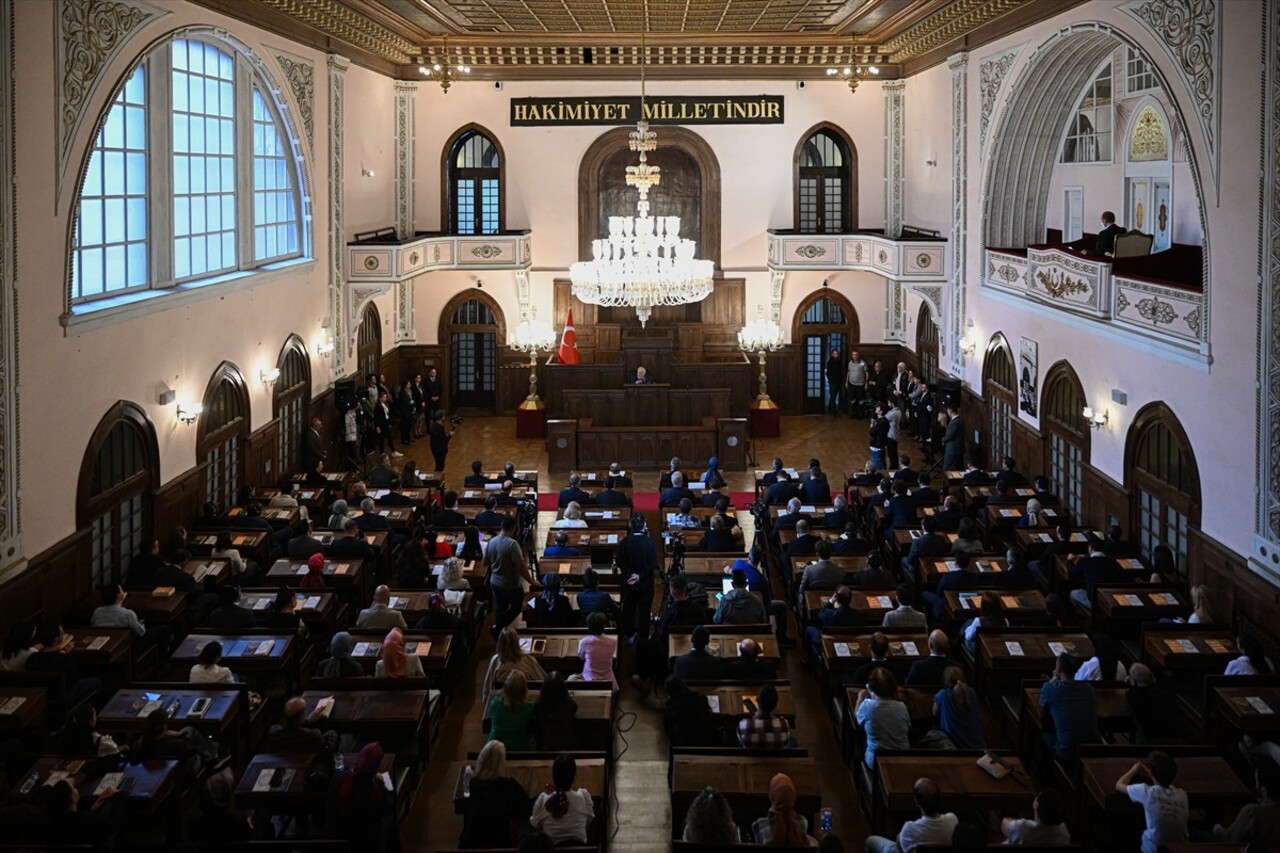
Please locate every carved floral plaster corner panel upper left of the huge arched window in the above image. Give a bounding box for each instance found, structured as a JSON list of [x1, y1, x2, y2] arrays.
[[54, 0, 169, 204]]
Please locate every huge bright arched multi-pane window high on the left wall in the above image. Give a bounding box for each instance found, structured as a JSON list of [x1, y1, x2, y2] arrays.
[[70, 32, 308, 313]]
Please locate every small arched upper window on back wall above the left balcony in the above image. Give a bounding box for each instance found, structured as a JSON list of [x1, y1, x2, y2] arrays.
[[444, 127, 506, 234]]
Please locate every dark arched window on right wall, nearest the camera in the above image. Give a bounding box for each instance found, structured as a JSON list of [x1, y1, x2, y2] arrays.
[[1125, 402, 1201, 579]]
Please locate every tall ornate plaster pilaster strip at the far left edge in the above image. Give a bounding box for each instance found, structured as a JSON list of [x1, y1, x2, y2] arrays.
[[0, 0, 27, 578]]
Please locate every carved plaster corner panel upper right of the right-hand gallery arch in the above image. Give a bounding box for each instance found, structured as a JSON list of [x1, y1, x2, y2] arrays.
[[1120, 0, 1223, 199]]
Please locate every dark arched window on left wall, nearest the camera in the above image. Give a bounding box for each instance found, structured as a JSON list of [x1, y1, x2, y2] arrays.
[[76, 401, 160, 587]]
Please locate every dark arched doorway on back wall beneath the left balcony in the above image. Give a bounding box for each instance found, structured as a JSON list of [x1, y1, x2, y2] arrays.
[[440, 289, 507, 411]]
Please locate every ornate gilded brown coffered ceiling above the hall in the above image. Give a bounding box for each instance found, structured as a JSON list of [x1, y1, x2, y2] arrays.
[[193, 0, 1084, 79]]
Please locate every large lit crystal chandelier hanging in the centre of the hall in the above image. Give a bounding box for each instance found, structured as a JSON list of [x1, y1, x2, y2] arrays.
[[568, 10, 716, 327]]
